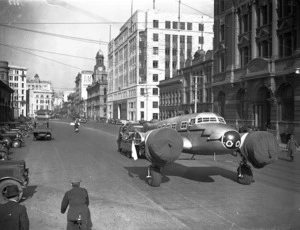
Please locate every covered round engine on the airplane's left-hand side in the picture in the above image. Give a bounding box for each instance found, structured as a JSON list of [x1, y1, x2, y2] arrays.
[[145, 128, 183, 167]]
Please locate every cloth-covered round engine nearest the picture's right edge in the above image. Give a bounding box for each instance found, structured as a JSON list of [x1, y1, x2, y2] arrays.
[[240, 131, 280, 168]]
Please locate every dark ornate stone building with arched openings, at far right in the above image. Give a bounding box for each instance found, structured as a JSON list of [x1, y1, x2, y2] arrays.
[[212, 0, 300, 142]]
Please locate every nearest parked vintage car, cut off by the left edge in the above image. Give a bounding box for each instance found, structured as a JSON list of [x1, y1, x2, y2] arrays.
[[0, 160, 29, 203]]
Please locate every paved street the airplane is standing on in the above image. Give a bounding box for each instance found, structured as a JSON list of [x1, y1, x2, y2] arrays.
[[11, 121, 300, 230]]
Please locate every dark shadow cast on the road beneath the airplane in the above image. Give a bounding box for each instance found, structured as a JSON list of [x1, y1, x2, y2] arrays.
[[125, 163, 237, 186]]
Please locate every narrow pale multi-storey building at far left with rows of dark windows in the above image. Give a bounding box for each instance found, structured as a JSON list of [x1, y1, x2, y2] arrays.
[[8, 65, 27, 118]]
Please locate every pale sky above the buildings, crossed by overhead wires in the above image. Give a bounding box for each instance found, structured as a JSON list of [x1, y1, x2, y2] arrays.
[[0, 0, 214, 90]]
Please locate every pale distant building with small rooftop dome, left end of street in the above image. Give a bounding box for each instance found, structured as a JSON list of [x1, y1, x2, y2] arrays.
[[27, 74, 54, 117]]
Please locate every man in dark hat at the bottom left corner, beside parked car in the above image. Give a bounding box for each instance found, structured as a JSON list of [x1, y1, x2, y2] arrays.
[[0, 185, 29, 230]]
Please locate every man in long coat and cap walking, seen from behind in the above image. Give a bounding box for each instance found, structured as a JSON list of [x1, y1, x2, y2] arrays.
[[61, 179, 92, 230]]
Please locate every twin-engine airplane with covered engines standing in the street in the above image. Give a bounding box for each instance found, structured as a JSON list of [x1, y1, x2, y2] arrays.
[[126, 112, 280, 187]]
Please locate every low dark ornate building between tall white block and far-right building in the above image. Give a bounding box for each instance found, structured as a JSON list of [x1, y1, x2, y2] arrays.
[[159, 49, 213, 119]]
